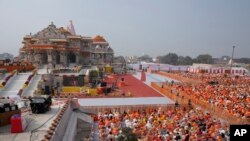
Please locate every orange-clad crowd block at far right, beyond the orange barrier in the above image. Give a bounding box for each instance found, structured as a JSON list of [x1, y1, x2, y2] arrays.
[[169, 73, 250, 120]]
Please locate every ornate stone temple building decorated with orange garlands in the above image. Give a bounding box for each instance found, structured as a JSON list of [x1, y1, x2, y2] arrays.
[[19, 21, 114, 68]]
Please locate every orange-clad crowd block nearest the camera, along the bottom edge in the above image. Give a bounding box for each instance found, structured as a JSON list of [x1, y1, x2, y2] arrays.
[[94, 108, 229, 141]]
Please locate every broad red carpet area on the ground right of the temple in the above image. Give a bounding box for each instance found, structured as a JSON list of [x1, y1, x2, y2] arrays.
[[120, 74, 163, 97]]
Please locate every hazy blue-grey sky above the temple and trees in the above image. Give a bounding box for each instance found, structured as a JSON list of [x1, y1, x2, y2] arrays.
[[0, 0, 250, 57]]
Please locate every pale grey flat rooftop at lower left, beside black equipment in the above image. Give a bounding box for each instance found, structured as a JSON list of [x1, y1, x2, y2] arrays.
[[0, 101, 64, 141]]
